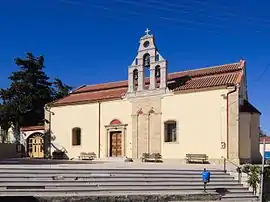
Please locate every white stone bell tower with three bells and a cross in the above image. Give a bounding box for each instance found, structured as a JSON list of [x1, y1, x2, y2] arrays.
[[127, 29, 167, 97]]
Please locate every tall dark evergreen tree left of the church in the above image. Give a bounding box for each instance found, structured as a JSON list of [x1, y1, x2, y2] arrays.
[[0, 53, 71, 142]]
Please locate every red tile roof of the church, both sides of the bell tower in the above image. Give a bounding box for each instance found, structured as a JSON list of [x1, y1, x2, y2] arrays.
[[51, 60, 245, 106]]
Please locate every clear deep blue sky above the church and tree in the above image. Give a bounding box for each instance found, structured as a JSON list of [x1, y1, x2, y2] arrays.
[[0, 0, 270, 134]]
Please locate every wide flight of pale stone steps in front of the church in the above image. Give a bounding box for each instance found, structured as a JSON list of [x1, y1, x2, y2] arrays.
[[0, 164, 257, 200]]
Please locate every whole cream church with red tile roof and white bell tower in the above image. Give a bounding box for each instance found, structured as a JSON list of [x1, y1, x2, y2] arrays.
[[45, 32, 260, 162]]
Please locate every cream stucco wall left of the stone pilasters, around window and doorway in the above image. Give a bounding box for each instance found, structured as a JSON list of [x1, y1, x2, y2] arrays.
[[51, 100, 132, 158]]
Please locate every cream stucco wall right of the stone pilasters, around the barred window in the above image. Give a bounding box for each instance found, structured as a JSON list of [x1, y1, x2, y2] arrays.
[[161, 89, 227, 159]]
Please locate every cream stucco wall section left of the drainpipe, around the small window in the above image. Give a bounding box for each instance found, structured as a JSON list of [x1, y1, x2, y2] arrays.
[[51, 103, 98, 158]]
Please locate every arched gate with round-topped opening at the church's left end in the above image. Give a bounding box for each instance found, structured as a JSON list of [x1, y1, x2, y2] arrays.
[[27, 133, 44, 158]]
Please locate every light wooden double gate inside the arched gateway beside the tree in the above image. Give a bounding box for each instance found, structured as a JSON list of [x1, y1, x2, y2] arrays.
[[29, 136, 44, 158]]
